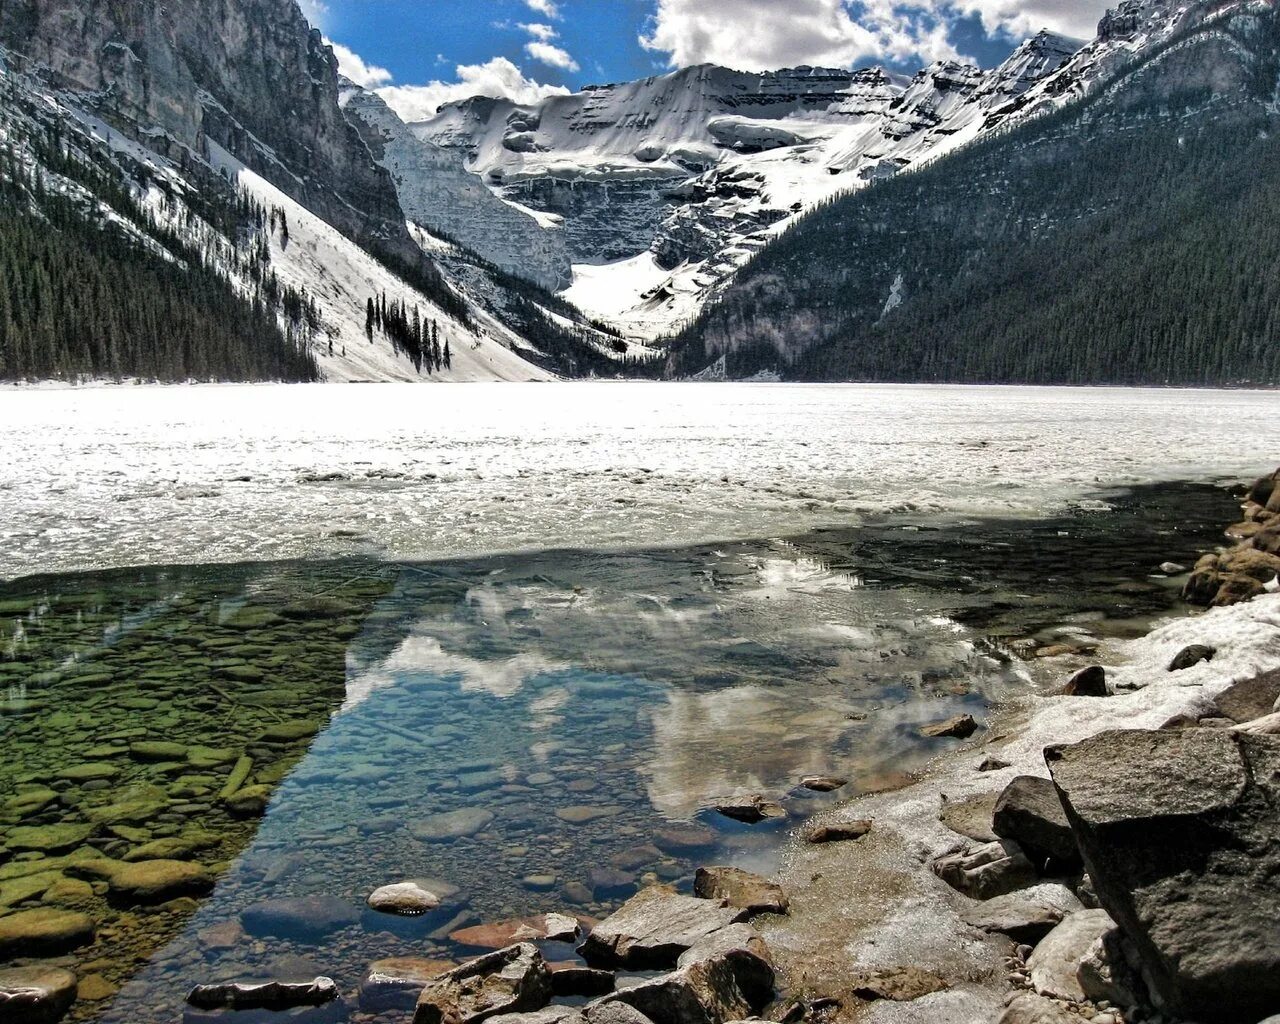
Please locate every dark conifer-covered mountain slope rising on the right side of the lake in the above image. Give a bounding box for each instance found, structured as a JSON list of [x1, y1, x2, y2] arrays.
[[669, 0, 1280, 384]]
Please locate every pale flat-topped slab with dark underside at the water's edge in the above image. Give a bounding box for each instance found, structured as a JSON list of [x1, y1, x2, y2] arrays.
[[579, 886, 749, 969]]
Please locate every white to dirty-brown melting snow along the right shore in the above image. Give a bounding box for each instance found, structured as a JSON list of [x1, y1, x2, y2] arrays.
[[765, 595, 1280, 1024]]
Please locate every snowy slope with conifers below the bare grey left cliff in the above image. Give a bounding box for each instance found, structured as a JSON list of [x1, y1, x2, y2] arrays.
[[0, 42, 549, 380]]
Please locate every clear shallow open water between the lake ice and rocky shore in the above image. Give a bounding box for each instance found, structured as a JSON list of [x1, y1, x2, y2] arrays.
[[0, 486, 1233, 1024]]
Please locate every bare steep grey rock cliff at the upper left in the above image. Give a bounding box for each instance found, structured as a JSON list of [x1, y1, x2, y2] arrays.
[[0, 0, 415, 255]]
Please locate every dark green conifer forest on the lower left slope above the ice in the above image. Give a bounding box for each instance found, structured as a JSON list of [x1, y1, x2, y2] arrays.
[[0, 88, 321, 381]]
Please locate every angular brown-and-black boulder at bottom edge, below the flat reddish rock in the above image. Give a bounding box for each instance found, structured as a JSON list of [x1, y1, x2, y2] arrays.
[[413, 942, 552, 1024]]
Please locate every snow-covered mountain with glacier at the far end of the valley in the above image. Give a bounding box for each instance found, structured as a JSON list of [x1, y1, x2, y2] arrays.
[[402, 33, 1080, 337]]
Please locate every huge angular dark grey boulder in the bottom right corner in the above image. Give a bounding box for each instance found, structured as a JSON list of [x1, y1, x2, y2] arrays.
[[1046, 728, 1280, 1024]]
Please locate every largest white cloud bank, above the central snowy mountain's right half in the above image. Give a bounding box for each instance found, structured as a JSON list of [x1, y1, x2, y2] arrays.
[[640, 0, 1108, 70]]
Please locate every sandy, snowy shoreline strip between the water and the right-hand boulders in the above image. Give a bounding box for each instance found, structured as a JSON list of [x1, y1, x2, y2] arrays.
[[759, 476, 1280, 1024]]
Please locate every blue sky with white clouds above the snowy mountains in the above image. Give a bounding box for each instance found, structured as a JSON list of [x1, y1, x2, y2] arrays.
[[300, 0, 1107, 119]]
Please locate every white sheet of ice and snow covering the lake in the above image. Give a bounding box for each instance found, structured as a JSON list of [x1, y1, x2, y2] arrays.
[[0, 383, 1280, 579]]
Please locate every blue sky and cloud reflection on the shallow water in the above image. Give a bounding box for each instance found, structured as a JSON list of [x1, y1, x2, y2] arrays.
[[92, 544, 1025, 1024]]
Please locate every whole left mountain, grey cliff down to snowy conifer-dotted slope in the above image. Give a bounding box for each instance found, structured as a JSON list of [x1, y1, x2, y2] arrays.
[[0, 0, 646, 380]]
